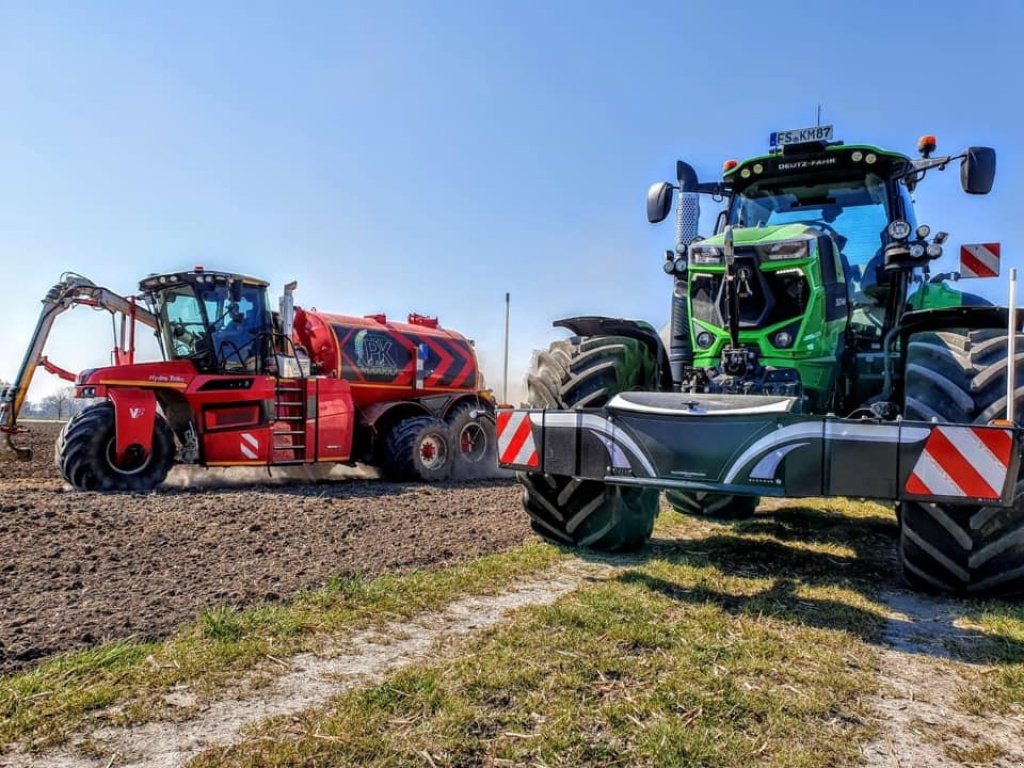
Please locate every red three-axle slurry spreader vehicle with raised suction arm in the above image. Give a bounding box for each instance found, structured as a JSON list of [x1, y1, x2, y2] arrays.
[[0, 266, 496, 490]]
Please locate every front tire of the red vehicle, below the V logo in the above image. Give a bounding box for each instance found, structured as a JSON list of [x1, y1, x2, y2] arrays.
[[54, 402, 174, 490]]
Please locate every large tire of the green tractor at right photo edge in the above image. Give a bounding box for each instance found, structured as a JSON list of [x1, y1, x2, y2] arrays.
[[897, 331, 1024, 597]]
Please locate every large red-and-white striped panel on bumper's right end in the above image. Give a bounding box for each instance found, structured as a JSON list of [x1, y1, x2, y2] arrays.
[[906, 426, 1014, 499]]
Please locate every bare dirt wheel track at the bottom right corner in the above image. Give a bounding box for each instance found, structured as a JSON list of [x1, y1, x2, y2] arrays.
[[861, 591, 1024, 768]]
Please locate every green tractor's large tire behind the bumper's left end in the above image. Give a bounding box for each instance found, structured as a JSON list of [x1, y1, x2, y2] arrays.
[[516, 336, 658, 552]]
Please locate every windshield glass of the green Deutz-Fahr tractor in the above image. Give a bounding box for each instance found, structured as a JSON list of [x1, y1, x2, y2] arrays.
[[729, 173, 891, 336]]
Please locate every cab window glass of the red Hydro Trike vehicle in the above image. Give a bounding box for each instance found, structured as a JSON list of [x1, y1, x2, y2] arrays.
[[160, 283, 269, 372]]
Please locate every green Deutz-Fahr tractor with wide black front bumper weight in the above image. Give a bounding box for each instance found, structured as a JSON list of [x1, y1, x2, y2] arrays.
[[498, 126, 1024, 595]]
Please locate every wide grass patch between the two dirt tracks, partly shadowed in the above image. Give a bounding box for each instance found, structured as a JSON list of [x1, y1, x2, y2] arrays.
[[194, 502, 895, 768]]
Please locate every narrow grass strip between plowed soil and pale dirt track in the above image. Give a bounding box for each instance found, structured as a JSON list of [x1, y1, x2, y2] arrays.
[[0, 544, 563, 749]]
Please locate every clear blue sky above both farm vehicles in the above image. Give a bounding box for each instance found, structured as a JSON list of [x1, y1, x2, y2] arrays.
[[0, 0, 1024, 405]]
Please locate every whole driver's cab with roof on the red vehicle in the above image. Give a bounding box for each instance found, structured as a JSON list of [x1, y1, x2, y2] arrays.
[[139, 267, 272, 374]]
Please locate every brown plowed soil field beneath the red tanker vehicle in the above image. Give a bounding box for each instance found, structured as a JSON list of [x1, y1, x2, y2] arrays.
[[0, 423, 529, 674]]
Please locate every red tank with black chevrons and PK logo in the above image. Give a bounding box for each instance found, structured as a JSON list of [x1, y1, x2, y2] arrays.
[[292, 307, 480, 408]]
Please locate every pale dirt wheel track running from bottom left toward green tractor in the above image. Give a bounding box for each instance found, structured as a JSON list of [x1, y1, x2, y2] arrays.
[[0, 559, 618, 768]]
